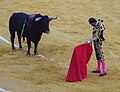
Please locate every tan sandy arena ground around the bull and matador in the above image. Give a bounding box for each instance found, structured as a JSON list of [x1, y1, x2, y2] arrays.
[[0, 0, 120, 92]]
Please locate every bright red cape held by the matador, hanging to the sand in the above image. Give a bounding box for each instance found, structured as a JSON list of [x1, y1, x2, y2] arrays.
[[66, 44, 93, 82]]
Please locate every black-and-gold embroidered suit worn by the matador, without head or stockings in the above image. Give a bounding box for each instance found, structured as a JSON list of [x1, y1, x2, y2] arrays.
[[92, 21, 105, 61]]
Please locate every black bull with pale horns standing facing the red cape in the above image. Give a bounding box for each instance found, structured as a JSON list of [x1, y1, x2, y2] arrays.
[[9, 12, 56, 55]]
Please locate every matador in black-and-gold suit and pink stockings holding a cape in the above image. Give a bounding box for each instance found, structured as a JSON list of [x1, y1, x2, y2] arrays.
[[87, 18, 107, 76]]
